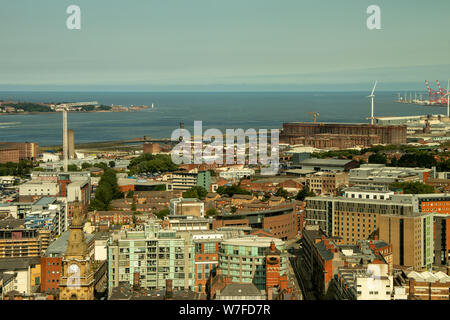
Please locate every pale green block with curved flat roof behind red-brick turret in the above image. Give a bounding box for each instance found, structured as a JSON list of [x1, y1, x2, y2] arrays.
[[219, 236, 289, 290]]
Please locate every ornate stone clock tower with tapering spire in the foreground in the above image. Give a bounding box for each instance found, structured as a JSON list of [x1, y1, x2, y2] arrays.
[[59, 202, 94, 300]]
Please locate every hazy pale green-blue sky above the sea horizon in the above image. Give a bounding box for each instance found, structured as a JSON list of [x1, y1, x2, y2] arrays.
[[0, 0, 450, 91]]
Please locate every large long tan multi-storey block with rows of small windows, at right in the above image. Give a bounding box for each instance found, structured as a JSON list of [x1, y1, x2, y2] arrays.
[[306, 197, 433, 269]]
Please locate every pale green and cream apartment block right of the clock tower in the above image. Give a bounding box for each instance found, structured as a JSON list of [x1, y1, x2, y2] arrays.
[[108, 224, 194, 293]]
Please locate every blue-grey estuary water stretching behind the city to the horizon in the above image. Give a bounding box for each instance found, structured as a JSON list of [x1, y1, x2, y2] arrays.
[[0, 91, 438, 146]]
